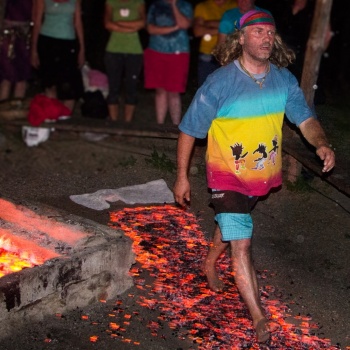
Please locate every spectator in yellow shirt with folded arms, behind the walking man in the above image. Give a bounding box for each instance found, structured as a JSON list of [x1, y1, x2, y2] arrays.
[[193, 0, 237, 86]]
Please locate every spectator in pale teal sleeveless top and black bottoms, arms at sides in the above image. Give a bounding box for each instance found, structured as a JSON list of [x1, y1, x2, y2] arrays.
[[31, 0, 85, 111]]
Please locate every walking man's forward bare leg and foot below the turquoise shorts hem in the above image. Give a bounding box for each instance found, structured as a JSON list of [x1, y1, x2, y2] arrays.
[[230, 239, 270, 342]]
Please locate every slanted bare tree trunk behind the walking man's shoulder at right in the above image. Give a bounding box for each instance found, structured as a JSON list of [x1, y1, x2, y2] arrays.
[[300, 0, 332, 106]]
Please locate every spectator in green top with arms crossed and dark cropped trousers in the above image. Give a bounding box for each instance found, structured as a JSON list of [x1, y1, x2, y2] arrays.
[[104, 0, 146, 123]]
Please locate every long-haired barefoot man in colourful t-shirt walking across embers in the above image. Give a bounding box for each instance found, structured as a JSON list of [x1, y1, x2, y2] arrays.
[[174, 10, 335, 343]]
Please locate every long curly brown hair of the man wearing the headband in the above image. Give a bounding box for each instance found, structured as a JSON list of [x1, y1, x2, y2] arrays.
[[213, 29, 295, 68]]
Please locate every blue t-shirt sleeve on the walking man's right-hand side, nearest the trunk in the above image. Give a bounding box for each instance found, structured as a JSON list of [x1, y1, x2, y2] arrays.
[[285, 70, 316, 126]]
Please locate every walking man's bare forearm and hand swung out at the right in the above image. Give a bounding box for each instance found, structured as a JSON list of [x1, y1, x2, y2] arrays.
[[299, 118, 335, 172]]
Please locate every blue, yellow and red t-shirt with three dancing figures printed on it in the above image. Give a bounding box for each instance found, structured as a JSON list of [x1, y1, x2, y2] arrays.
[[179, 61, 312, 196]]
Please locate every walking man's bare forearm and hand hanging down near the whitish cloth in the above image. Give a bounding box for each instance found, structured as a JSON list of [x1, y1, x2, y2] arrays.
[[173, 132, 195, 207]]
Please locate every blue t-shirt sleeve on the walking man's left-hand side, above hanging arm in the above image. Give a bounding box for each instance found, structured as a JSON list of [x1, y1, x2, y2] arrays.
[[179, 76, 219, 139]]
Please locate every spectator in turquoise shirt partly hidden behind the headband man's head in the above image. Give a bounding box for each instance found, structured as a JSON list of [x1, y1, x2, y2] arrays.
[[218, 0, 269, 44]]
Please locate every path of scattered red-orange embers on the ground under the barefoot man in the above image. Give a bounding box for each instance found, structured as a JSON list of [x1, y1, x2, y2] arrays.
[[109, 206, 338, 350]]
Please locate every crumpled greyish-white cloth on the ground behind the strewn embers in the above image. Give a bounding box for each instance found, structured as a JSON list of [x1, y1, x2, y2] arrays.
[[69, 179, 174, 210]]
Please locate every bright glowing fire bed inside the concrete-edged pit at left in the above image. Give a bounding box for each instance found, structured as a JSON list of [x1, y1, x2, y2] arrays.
[[0, 198, 87, 277]]
